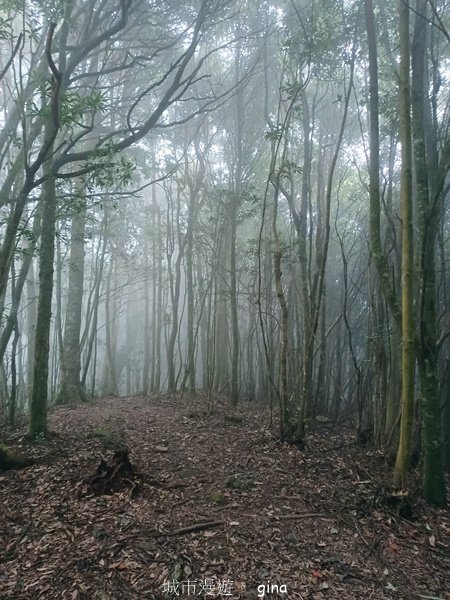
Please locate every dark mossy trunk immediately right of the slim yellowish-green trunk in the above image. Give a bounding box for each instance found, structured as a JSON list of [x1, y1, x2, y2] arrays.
[[411, 0, 447, 506]]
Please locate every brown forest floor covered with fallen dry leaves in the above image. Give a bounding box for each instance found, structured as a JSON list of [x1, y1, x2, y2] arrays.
[[0, 396, 450, 600]]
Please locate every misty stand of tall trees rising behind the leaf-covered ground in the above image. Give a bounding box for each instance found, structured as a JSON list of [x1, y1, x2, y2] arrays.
[[0, 0, 450, 505]]
